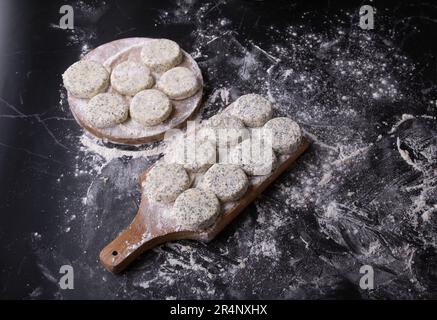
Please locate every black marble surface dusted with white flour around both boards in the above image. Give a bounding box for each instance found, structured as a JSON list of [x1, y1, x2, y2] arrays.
[[0, 0, 437, 299]]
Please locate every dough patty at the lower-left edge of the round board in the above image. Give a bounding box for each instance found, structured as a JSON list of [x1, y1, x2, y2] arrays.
[[84, 93, 129, 128]]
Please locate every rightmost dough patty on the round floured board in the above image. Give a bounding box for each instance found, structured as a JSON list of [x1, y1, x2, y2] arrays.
[[157, 67, 200, 100]]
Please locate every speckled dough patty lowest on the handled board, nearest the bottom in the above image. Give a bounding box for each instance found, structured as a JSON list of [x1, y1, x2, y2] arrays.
[[172, 188, 220, 230]]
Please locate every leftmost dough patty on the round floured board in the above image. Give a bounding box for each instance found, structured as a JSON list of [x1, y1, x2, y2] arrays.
[[62, 60, 109, 99]]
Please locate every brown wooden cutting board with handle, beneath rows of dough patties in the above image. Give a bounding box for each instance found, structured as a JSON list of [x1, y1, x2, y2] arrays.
[[100, 139, 309, 273]]
